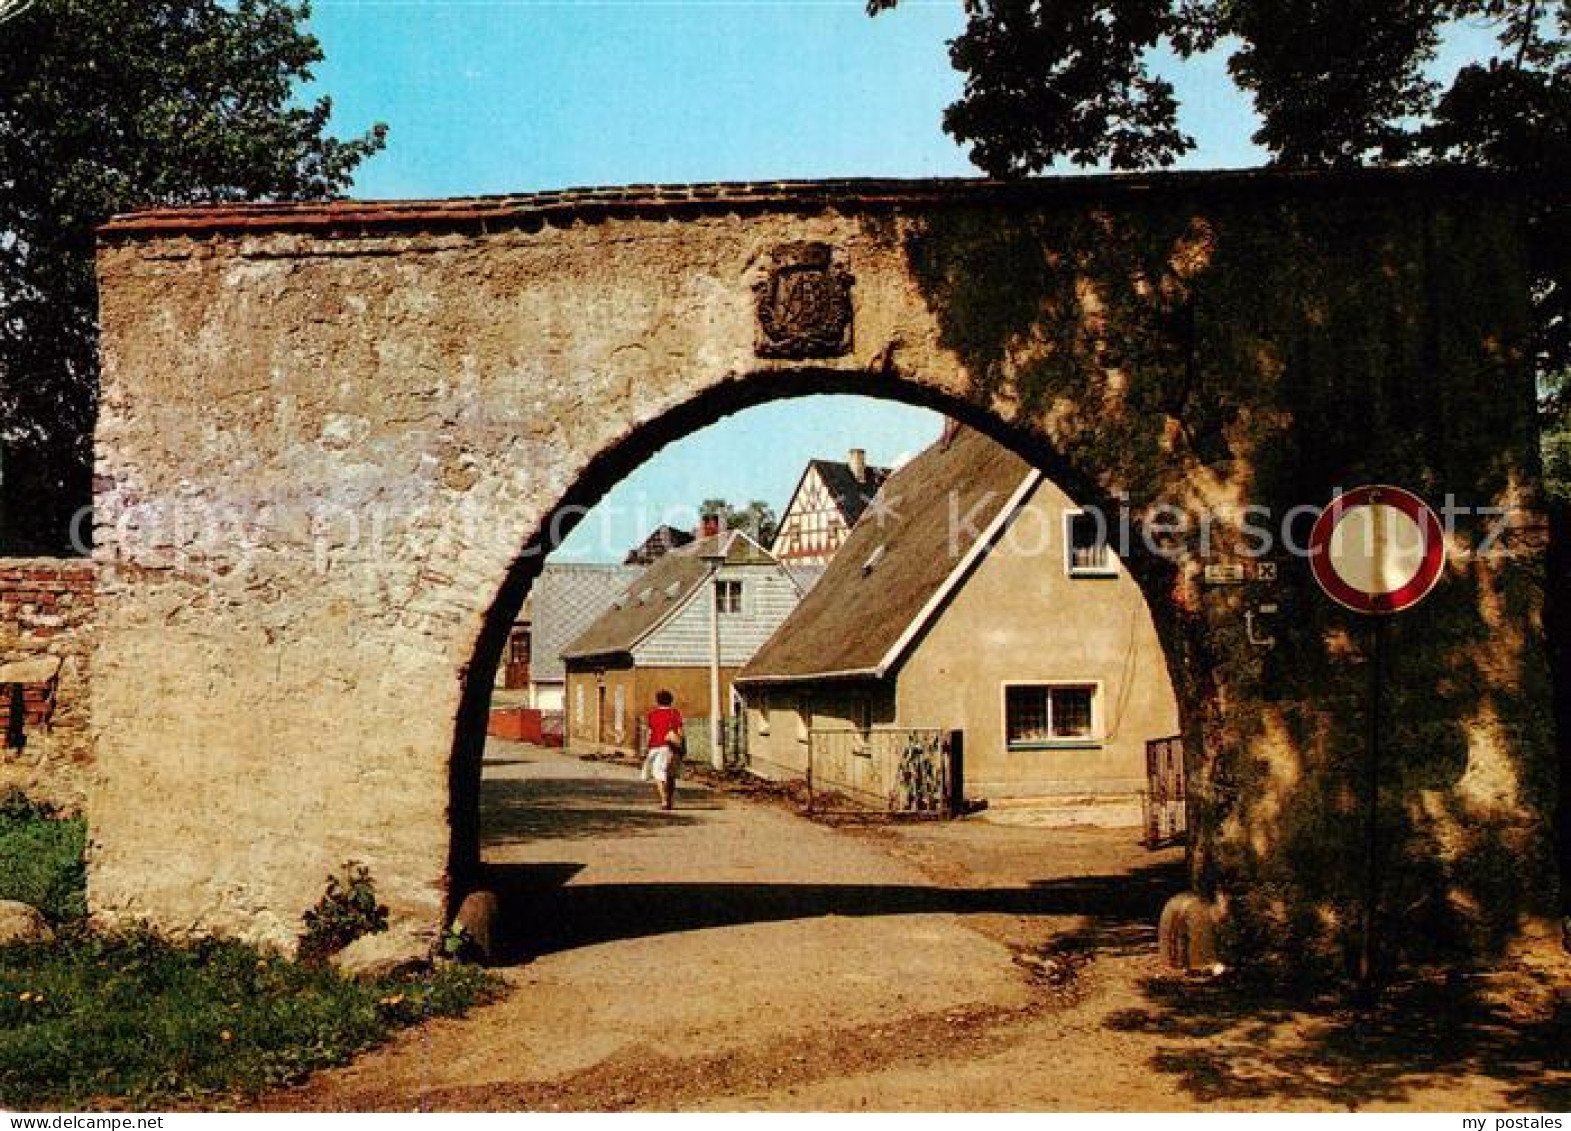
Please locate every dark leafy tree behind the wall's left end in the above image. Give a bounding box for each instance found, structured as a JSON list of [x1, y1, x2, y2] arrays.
[[0, 0, 385, 551]]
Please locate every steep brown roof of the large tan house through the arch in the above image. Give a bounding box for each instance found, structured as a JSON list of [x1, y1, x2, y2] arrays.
[[737, 429, 1034, 683]]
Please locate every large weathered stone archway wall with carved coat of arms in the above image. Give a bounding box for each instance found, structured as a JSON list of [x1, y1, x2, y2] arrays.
[[90, 174, 1555, 952]]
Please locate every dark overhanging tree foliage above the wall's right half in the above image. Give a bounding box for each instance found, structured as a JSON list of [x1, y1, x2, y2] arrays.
[[867, 0, 1571, 496]]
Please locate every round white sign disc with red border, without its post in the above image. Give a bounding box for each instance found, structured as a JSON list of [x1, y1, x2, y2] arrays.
[[1309, 485, 1445, 613]]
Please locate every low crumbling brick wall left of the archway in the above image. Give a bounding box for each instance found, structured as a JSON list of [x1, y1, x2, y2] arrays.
[[0, 558, 94, 809]]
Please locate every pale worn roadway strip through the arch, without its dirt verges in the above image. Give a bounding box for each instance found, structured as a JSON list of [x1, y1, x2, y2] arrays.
[[278, 745, 1034, 1107]]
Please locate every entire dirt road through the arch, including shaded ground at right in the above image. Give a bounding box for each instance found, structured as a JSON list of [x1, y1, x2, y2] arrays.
[[265, 745, 1571, 1111]]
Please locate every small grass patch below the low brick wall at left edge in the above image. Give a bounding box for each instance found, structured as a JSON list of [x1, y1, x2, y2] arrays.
[[0, 792, 88, 924]]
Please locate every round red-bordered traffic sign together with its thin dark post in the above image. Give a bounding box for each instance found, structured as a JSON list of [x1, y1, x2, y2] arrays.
[[1309, 485, 1445, 1004]]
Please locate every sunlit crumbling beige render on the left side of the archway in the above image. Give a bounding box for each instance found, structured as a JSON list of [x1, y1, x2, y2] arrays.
[[91, 205, 955, 943]]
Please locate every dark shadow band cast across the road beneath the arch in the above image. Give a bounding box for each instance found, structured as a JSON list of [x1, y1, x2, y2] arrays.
[[471, 862, 1183, 961]]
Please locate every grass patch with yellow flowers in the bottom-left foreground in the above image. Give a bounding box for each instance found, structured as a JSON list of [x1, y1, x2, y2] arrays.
[[0, 928, 498, 1109]]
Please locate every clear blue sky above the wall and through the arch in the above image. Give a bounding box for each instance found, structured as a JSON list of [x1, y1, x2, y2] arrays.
[[311, 0, 1495, 559]]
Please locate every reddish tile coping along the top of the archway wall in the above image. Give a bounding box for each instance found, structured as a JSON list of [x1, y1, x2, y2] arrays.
[[99, 170, 1503, 240]]
